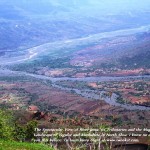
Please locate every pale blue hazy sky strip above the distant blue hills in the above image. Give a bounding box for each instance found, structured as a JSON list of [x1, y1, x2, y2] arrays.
[[0, 0, 150, 14]]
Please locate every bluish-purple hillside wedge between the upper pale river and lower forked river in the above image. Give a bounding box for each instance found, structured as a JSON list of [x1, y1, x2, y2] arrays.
[[9, 32, 150, 77]]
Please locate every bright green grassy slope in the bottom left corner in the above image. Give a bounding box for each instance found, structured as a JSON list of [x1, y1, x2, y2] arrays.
[[0, 140, 53, 150]]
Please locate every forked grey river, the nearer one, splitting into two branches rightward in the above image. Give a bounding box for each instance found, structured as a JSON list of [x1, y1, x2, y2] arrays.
[[0, 69, 150, 111]]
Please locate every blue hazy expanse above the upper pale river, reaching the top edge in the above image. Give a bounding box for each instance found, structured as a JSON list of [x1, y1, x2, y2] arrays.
[[0, 0, 150, 55]]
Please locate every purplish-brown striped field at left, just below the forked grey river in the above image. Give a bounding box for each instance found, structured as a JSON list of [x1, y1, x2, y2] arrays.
[[0, 82, 108, 114]]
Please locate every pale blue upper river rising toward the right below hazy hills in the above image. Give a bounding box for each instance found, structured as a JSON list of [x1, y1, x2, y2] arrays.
[[0, 25, 150, 65]]
